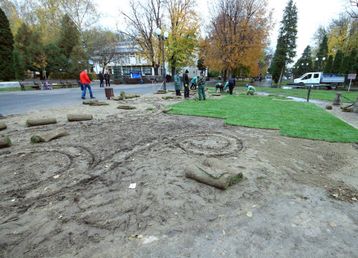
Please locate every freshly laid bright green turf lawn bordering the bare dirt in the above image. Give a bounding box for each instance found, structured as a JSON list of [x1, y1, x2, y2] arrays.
[[169, 95, 358, 142]]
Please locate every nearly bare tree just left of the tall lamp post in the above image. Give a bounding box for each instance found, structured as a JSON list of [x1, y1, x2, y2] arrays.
[[122, 0, 162, 75]]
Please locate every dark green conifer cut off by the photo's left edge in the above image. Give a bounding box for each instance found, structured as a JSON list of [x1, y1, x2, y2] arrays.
[[0, 8, 14, 81]]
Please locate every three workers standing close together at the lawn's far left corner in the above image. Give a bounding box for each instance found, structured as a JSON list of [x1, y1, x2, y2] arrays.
[[174, 70, 206, 100]]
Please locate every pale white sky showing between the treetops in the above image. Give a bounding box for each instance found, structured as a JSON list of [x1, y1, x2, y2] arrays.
[[96, 0, 348, 59]]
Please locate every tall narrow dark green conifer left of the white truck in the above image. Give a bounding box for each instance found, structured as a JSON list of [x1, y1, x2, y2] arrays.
[[270, 0, 297, 83]]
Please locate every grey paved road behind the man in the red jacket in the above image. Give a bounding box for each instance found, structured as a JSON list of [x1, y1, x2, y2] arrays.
[[0, 84, 174, 115]]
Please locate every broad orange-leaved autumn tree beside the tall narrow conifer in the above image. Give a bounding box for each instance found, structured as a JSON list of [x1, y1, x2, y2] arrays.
[[201, 0, 271, 79]]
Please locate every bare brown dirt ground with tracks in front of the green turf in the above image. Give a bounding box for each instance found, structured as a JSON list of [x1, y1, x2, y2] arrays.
[[0, 95, 358, 257]]
